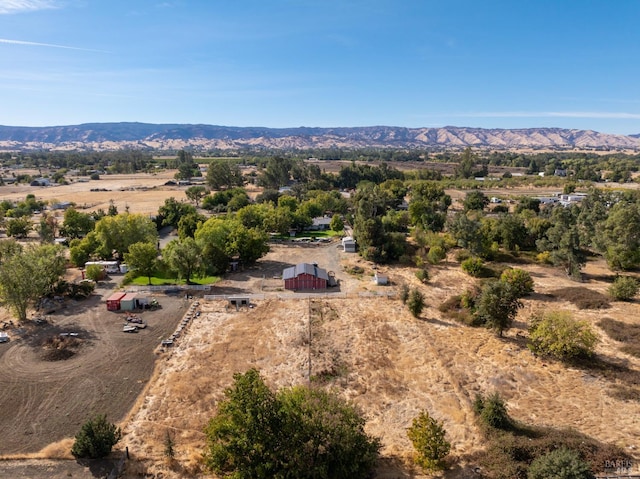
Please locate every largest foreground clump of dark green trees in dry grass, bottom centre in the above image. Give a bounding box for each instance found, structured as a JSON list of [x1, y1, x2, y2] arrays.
[[205, 369, 380, 479]]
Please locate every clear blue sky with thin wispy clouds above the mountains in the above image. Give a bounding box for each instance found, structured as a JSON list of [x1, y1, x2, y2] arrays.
[[0, 0, 640, 134]]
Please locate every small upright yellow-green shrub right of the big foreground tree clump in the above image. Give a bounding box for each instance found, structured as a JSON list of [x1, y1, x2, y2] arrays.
[[407, 411, 451, 471]]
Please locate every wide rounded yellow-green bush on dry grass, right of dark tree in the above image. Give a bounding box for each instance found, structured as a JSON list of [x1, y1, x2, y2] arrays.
[[528, 311, 598, 360]]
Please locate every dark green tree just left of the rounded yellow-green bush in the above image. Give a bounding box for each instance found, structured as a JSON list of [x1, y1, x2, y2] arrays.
[[475, 281, 522, 336]]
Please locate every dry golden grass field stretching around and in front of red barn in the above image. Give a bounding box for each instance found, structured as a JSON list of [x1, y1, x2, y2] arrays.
[[116, 247, 640, 478]]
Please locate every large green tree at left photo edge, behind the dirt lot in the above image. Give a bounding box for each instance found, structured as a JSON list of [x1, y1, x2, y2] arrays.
[[0, 245, 66, 321]]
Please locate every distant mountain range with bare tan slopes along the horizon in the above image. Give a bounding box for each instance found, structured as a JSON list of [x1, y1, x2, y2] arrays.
[[0, 123, 640, 151]]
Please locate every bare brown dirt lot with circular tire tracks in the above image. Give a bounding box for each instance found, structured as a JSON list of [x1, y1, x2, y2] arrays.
[[0, 283, 189, 455]]
